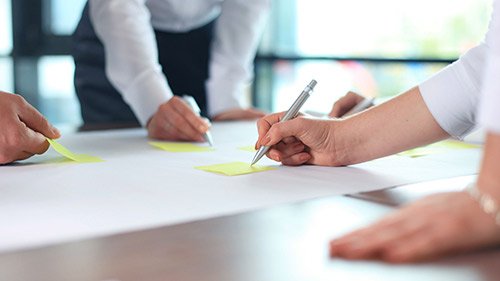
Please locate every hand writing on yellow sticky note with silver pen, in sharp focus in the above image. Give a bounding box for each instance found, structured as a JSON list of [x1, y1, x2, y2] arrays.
[[255, 112, 348, 166]]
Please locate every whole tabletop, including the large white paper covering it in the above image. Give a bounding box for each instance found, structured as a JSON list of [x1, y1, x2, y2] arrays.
[[0, 122, 492, 281]]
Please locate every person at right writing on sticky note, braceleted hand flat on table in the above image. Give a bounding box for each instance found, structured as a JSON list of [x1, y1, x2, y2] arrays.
[[256, 0, 500, 263]]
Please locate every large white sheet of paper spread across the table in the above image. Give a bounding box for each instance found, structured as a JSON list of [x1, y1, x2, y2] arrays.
[[0, 122, 481, 251]]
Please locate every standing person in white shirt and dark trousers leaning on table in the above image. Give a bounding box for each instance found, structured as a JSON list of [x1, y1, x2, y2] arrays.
[[72, 0, 270, 141]]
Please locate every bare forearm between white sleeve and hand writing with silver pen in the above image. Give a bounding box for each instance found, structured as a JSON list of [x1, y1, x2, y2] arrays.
[[337, 87, 449, 164]]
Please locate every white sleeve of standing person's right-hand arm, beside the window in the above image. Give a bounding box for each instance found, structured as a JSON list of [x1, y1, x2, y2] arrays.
[[206, 0, 270, 117]]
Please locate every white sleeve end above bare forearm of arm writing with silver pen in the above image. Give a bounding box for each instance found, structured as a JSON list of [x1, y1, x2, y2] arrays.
[[419, 62, 478, 139]]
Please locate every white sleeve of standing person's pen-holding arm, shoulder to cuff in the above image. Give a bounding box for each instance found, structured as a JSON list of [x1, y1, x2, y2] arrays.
[[89, 0, 173, 126]]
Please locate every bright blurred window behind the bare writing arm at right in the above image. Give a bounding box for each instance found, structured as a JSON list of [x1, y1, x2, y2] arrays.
[[254, 0, 491, 113]]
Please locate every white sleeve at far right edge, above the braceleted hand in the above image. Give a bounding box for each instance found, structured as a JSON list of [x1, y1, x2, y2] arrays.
[[479, 0, 500, 134]]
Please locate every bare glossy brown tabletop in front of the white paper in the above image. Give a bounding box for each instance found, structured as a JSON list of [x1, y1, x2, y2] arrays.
[[0, 177, 500, 281]]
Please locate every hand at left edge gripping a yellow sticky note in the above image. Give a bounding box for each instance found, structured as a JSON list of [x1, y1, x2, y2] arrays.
[[0, 91, 61, 164]]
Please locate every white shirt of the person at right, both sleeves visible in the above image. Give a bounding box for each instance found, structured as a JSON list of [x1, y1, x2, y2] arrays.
[[419, 0, 500, 138]]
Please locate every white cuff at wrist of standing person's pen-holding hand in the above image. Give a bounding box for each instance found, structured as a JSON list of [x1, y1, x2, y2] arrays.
[[123, 70, 173, 127]]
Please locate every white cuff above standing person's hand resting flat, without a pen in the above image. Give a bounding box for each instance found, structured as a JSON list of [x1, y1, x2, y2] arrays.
[[206, 78, 245, 118]]
